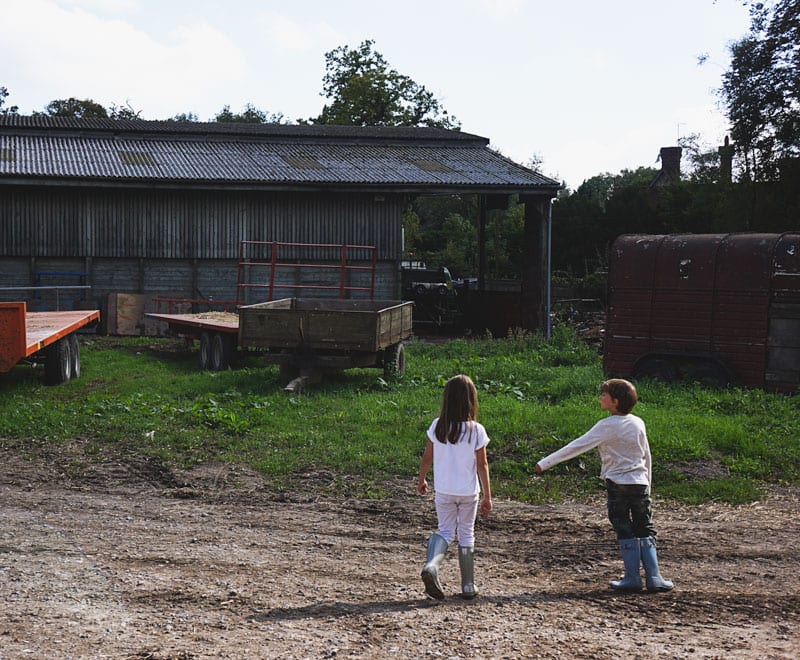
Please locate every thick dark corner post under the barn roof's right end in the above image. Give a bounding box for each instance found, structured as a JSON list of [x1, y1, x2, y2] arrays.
[[520, 195, 550, 332]]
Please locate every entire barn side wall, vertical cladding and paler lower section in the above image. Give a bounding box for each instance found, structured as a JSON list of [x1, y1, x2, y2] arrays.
[[0, 188, 405, 301]]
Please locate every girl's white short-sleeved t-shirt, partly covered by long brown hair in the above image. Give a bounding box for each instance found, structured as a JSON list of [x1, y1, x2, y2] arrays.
[[428, 417, 489, 495]]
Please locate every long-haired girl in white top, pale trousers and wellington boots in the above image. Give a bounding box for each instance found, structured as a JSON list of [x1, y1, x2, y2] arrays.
[[417, 375, 492, 600]]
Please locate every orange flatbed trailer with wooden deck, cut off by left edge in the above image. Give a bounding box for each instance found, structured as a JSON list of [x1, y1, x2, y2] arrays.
[[0, 302, 100, 385]]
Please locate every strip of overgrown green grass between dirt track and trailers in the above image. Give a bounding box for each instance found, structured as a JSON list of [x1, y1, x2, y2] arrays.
[[0, 327, 800, 503]]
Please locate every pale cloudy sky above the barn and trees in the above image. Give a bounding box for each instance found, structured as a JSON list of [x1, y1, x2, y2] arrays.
[[0, 0, 749, 190]]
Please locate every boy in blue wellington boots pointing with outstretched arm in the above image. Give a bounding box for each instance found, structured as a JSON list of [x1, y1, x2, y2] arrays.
[[534, 378, 673, 591]]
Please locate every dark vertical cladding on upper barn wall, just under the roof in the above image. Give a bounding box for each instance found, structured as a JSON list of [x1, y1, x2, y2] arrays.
[[0, 188, 404, 261]]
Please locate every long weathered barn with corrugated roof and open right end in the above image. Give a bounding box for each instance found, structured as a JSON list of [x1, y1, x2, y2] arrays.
[[0, 115, 559, 329]]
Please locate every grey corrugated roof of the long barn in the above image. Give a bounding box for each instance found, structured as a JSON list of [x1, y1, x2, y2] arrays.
[[0, 116, 559, 193]]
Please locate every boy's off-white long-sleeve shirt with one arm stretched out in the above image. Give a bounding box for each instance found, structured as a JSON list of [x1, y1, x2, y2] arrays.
[[539, 414, 652, 486]]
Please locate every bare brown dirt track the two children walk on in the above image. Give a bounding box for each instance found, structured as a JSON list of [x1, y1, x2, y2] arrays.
[[0, 440, 800, 659]]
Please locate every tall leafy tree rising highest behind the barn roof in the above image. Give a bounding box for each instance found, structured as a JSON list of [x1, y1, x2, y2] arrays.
[[308, 39, 460, 128]]
